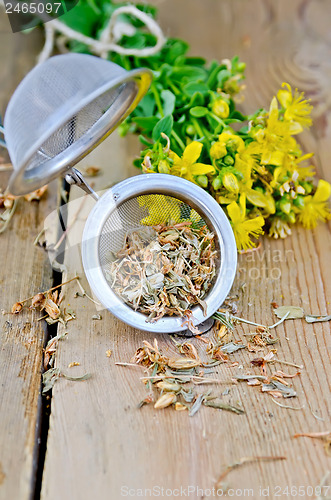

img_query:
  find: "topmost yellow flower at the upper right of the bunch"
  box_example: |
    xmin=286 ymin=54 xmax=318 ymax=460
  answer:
xmin=277 ymin=82 xmax=313 ymax=133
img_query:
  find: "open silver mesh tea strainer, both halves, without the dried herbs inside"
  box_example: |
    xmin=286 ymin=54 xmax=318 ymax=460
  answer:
xmin=4 ymin=54 xmax=237 ymax=333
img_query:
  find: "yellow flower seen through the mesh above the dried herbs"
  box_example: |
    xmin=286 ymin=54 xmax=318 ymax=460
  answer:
xmin=137 ymin=194 xmax=181 ymax=226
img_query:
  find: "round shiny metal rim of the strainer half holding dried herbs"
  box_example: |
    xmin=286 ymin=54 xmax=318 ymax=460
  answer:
xmin=82 ymin=174 xmax=237 ymax=333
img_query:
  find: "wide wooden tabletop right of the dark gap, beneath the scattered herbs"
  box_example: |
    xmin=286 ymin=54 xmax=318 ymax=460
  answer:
xmin=42 ymin=0 xmax=331 ymax=500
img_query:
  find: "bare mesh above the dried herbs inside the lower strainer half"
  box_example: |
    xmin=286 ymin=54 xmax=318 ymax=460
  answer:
xmin=99 ymin=194 xmax=217 ymax=279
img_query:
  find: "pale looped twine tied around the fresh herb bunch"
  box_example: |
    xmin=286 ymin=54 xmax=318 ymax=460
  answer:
xmin=37 ymin=5 xmax=166 ymax=64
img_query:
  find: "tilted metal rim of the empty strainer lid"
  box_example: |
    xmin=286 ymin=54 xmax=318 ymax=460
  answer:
xmin=4 ymin=61 xmax=153 ymax=196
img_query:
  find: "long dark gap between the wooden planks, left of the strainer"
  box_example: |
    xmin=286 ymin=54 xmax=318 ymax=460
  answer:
xmin=30 ymin=180 xmax=70 ymax=500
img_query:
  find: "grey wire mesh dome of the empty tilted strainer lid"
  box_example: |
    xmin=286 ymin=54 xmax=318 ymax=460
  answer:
xmin=4 ymin=54 xmax=137 ymax=169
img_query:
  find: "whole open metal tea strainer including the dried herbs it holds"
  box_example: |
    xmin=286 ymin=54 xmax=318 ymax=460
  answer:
xmin=4 ymin=54 xmax=237 ymax=333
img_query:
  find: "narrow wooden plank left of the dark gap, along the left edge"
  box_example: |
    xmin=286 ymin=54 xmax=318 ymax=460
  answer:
xmin=0 ymin=10 xmax=56 ymax=500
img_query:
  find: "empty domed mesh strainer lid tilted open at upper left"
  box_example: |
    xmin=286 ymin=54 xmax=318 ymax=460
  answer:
xmin=4 ymin=54 xmax=152 ymax=195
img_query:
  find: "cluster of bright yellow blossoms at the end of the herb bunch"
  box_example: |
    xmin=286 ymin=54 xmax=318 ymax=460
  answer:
xmin=131 ymin=83 xmax=331 ymax=250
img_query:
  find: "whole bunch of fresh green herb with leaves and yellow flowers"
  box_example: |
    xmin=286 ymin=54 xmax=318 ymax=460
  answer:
xmin=63 ymin=0 xmax=331 ymax=250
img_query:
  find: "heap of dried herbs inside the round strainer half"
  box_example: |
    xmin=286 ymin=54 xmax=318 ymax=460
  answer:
xmin=106 ymin=221 xmax=218 ymax=330
